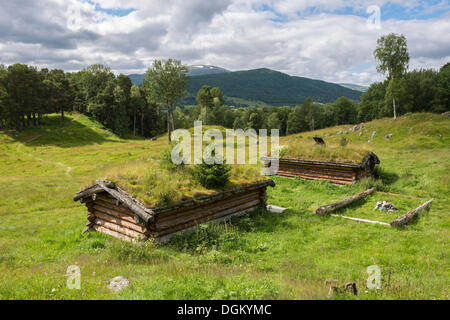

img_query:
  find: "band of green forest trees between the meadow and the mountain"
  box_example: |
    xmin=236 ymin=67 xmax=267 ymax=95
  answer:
xmin=0 ymin=63 xmax=450 ymax=137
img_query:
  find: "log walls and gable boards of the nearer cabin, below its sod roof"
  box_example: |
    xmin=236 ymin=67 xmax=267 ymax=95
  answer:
xmin=74 ymin=179 xmax=275 ymax=242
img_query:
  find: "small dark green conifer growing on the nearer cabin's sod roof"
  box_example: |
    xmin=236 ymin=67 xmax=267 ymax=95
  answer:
xmin=193 ymin=160 xmax=231 ymax=189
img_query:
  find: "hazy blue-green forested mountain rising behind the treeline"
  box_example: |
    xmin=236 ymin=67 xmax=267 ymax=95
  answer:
xmin=129 ymin=66 xmax=362 ymax=106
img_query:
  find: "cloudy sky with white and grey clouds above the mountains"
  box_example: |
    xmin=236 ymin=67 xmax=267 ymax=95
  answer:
xmin=0 ymin=0 xmax=450 ymax=84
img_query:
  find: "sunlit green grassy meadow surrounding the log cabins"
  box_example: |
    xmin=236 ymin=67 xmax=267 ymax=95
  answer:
xmin=0 ymin=114 xmax=450 ymax=299
